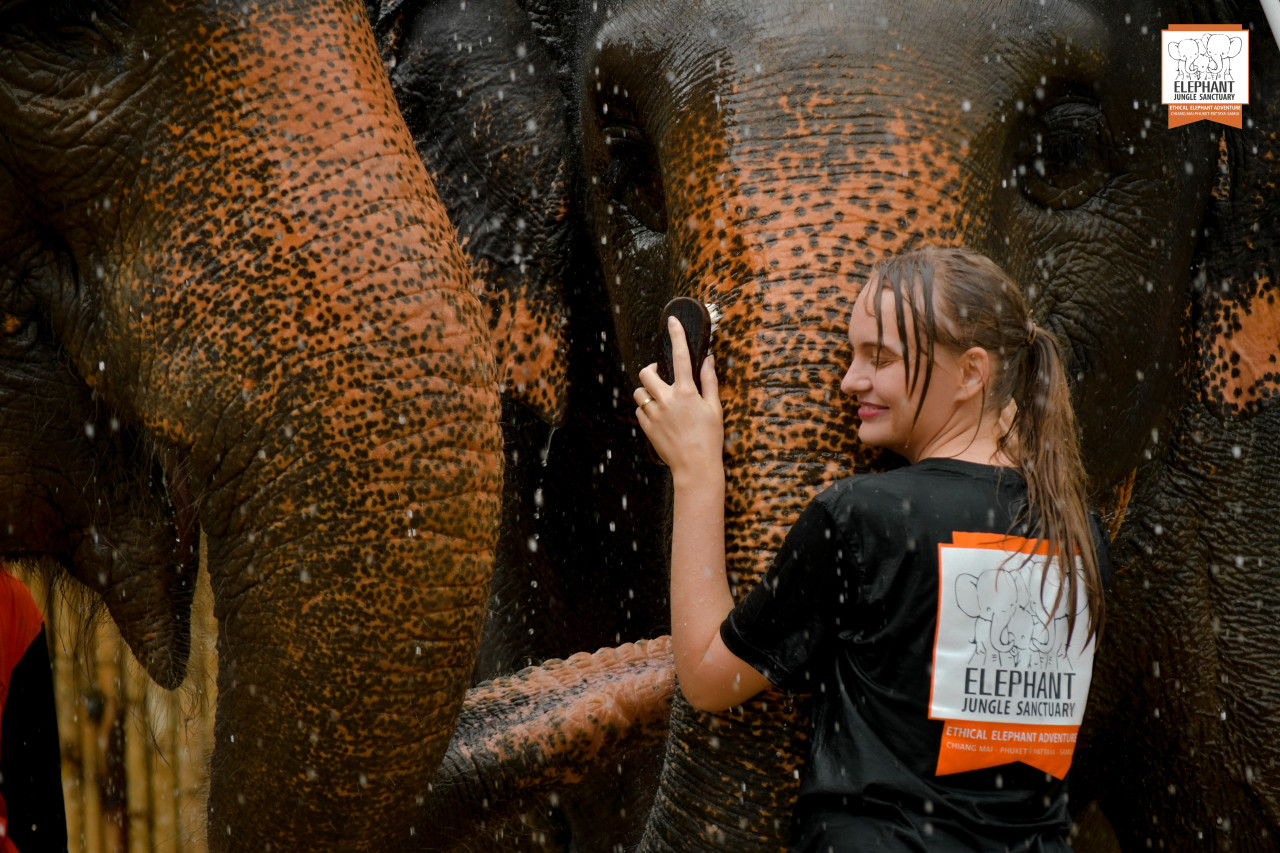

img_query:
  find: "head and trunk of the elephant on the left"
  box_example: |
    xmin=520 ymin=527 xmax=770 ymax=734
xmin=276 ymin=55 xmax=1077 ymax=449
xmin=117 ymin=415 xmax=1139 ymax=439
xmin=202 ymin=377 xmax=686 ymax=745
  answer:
xmin=0 ymin=0 xmax=500 ymax=849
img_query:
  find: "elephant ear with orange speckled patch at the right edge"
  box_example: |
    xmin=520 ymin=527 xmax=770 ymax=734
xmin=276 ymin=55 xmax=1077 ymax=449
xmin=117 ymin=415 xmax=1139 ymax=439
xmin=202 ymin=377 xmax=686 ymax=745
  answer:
xmin=1194 ymin=20 xmax=1280 ymax=418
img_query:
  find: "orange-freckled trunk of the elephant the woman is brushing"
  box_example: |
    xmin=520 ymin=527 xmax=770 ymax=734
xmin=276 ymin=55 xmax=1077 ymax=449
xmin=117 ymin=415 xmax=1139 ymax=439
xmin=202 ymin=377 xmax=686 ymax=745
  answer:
xmin=643 ymin=81 xmax=961 ymax=850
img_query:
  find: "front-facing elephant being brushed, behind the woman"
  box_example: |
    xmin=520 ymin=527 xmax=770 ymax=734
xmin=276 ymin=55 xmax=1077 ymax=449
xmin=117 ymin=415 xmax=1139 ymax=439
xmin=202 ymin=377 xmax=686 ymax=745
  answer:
xmin=371 ymin=0 xmax=1280 ymax=852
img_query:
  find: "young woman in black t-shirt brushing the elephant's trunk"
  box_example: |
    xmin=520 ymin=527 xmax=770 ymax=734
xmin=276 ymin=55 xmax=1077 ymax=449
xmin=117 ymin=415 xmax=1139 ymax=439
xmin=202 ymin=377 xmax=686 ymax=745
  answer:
xmin=635 ymin=247 xmax=1110 ymax=853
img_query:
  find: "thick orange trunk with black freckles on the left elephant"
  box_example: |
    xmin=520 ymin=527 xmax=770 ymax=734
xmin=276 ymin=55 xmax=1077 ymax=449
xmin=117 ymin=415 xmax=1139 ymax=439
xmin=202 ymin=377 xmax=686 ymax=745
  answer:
xmin=57 ymin=0 xmax=502 ymax=850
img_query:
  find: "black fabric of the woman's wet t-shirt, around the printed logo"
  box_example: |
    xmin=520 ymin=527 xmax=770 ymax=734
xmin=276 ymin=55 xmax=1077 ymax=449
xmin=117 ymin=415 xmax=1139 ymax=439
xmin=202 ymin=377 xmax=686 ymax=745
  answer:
xmin=721 ymin=459 xmax=1110 ymax=852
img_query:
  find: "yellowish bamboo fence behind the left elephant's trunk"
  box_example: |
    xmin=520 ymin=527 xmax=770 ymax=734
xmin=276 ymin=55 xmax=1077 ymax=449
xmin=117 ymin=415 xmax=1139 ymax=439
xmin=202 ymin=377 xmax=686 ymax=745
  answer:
xmin=28 ymin=558 xmax=218 ymax=853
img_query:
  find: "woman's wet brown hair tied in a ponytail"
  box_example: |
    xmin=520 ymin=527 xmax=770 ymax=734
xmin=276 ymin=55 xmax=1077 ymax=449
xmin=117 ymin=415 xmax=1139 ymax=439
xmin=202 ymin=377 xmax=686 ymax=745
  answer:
xmin=868 ymin=246 xmax=1103 ymax=642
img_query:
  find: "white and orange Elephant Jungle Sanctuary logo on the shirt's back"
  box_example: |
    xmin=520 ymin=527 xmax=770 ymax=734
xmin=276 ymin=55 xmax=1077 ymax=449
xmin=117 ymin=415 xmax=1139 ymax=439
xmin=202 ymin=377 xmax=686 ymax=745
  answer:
xmin=929 ymin=533 xmax=1094 ymax=779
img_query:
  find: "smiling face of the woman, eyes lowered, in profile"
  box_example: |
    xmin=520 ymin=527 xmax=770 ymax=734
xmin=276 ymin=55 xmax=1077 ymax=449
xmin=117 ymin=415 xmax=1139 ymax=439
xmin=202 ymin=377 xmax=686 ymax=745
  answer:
xmin=840 ymin=275 xmax=960 ymax=462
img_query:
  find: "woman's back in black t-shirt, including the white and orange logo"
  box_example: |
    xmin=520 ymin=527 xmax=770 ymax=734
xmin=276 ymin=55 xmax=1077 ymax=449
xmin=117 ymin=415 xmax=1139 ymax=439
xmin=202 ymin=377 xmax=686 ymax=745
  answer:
xmin=722 ymin=459 xmax=1106 ymax=849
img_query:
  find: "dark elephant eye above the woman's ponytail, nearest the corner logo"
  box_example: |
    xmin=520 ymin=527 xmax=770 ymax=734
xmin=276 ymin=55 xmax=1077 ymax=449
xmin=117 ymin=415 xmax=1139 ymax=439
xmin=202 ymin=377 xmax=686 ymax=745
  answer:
xmin=1018 ymin=101 xmax=1115 ymax=210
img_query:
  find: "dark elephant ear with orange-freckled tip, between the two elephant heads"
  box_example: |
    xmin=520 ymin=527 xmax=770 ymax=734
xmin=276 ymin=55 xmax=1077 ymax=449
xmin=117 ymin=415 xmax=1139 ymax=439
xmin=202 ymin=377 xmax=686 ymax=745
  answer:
xmin=371 ymin=0 xmax=570 ymax=425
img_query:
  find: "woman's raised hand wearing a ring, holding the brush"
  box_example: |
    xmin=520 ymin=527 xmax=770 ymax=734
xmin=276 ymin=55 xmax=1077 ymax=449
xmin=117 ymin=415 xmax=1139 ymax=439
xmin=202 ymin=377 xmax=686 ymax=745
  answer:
xmin=635 ymin=312 xmax=724 ymax=488
